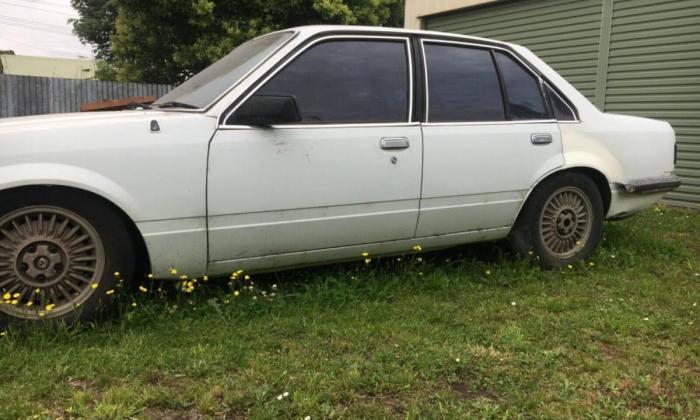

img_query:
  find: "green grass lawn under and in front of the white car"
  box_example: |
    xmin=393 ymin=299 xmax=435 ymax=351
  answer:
xmin=0 ymin=207 xmax=700 ymax=419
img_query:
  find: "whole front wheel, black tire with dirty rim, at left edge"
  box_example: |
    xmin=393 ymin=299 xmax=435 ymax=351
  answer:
xmin=0 ymin=187 xmax=135 ymax=327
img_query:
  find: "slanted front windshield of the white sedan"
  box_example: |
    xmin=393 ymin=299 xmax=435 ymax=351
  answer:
xmin=154 ymin=32 xmax=294 ymax=108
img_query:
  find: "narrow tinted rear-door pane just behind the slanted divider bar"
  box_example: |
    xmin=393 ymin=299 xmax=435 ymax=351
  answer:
xmin=495 ymin=52 xmax=549 ymax=120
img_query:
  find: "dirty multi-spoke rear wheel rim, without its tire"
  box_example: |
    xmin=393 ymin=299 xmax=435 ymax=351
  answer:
xmin=540 ymin=187 xmax=593 ymax=258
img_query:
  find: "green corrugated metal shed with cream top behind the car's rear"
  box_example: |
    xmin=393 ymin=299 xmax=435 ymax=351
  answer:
xmin=421 ymin=0 xmax=700 ymax=207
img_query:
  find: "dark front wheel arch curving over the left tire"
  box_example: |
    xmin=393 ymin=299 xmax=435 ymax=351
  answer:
xmin=0 ymin=184 xmax=151 ymax=274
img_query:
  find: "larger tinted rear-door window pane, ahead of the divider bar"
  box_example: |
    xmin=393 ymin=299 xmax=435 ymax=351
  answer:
xmin=425 ymin=44 xmax=505 ymax=122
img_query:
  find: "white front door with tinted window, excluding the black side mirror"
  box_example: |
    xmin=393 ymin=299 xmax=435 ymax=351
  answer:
xmin=207 ymin=36 xmax=422 ymax=262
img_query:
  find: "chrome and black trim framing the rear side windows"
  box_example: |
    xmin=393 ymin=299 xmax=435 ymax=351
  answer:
xmin=420 ymin=37 xmax=580 ymax=126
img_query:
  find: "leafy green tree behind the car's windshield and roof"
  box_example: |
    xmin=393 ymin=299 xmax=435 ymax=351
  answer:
xmin=71 ymin=0 xmax=403 ymax=84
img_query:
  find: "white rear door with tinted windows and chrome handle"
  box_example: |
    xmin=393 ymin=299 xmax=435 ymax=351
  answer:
xmin=416 ymin=40 xmax=564 ymax=236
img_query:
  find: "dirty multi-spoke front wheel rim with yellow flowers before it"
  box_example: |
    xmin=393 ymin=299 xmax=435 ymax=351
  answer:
xmin=0 ymin=207 xmax=105 ymax=319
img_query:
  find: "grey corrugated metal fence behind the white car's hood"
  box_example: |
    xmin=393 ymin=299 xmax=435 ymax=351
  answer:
xmin=0 ymin=74 xmax=172 ymax=118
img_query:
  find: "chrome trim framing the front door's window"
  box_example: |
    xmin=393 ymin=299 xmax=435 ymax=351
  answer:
xmin=218 ymin=34 xmax=416 ymax=129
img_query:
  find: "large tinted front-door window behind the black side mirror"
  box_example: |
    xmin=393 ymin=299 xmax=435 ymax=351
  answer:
xmin=230 ymin=40 xmax=409 ymax=124
